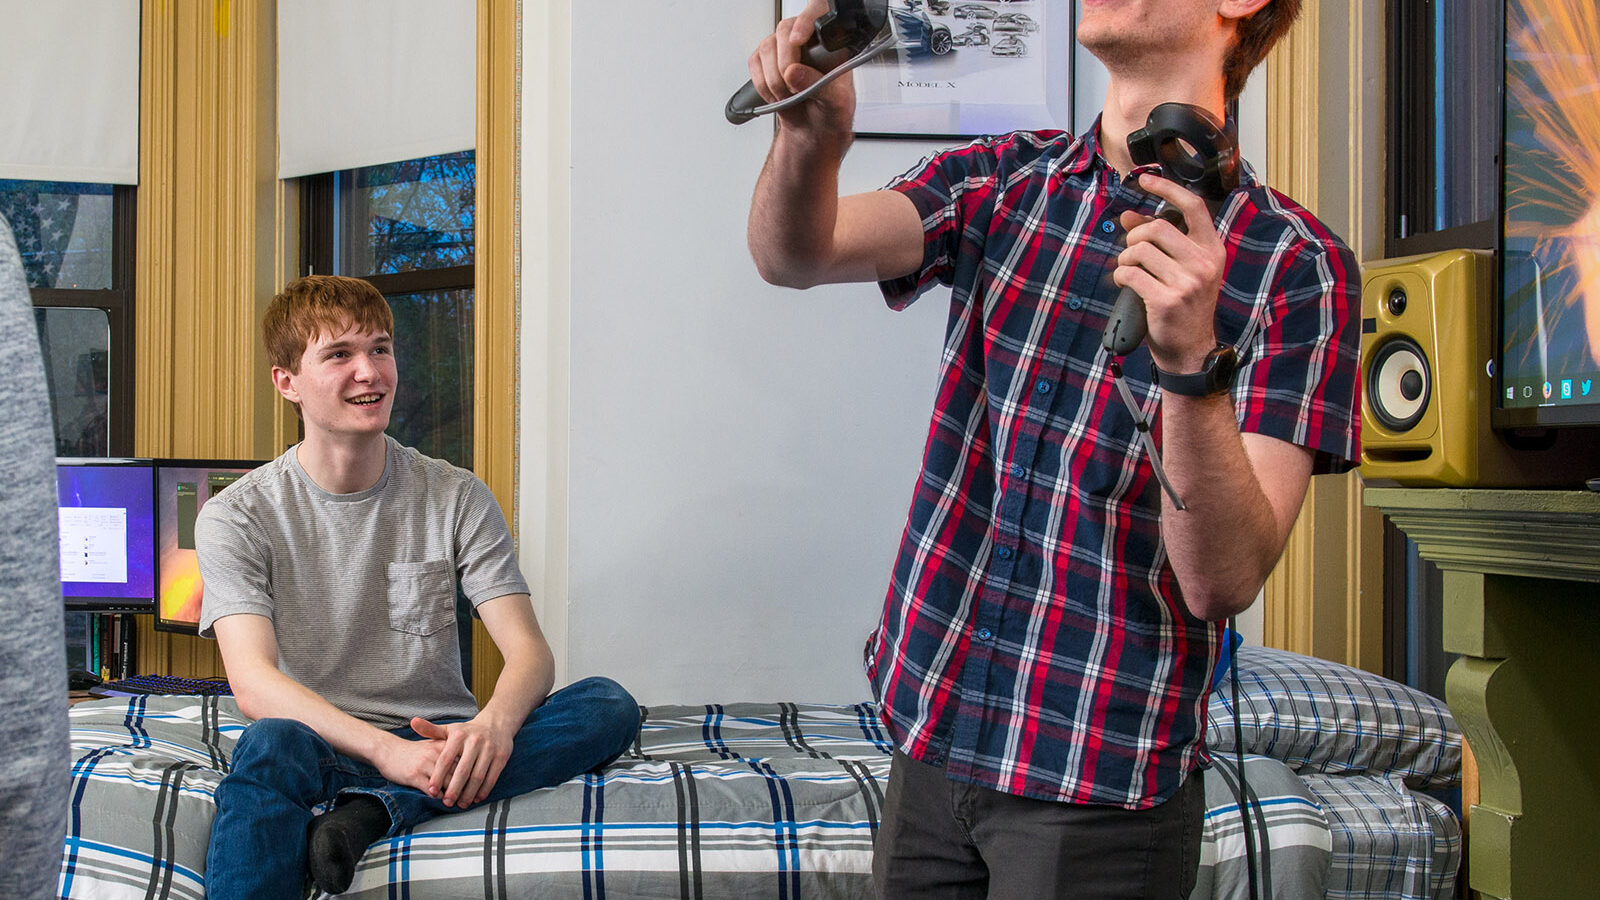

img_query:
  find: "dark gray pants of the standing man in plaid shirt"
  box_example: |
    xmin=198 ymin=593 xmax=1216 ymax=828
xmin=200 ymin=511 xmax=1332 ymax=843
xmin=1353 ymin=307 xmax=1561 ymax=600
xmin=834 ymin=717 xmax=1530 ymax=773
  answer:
xmin=872 ymin=751 xmax=1205 ymax=900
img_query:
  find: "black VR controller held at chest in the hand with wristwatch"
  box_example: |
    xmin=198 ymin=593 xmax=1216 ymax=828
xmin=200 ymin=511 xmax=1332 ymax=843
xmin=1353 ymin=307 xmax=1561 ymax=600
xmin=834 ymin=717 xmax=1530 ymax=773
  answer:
xmin=1101 ymin=102 xmax=1238 ymax=356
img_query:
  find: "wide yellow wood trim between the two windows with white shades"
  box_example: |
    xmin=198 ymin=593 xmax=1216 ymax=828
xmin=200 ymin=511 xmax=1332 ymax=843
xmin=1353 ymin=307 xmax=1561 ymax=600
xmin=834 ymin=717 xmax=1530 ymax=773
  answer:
xmin=134 ymin=0 xmax=285 ymax=676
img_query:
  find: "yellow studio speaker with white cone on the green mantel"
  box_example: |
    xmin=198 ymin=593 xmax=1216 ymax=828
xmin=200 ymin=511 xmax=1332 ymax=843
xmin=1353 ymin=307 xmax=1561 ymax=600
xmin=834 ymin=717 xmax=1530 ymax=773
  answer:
xmin=1362 ymin=250 xmax=1582 ymax=487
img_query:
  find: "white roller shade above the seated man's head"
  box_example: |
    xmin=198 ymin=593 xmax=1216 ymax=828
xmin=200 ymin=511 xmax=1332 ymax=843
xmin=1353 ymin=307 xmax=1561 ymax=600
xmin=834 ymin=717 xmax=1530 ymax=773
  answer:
xmin=278 ymin=0 xmax=477 ymax=178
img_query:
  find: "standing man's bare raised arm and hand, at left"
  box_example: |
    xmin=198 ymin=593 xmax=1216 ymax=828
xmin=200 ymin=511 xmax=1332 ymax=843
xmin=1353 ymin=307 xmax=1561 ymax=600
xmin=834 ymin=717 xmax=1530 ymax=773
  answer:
xmin=749 ymin=0 xmax=923 ymax=288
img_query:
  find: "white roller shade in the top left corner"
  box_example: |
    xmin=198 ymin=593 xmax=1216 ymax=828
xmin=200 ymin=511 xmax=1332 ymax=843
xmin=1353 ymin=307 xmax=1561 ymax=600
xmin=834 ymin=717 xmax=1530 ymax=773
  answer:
xmin=0 ymin=0 xmax=139 ymax=184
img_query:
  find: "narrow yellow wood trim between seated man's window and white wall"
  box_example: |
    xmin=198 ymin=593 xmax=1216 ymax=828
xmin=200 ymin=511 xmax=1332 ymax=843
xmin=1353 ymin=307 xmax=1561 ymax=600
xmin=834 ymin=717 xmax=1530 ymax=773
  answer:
xmin=472 ymin=0 xmax=522 ymax=703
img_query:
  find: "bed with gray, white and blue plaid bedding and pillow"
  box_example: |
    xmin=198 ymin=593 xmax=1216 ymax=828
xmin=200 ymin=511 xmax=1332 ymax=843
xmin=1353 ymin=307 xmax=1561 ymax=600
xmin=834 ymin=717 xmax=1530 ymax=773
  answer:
xmin=59 ymin=649 xmax=1462 ymax=900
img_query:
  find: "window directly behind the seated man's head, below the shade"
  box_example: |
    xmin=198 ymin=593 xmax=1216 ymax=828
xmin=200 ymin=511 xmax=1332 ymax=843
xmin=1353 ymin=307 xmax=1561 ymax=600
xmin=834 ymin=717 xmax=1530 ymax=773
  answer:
xmin=301 ymin=151 xmax=477 ymax=468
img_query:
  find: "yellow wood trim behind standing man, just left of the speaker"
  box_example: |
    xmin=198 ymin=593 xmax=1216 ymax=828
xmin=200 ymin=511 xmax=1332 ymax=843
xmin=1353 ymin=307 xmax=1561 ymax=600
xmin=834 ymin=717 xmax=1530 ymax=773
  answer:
xmin=1264 ymin=0 xmax=1384 ymax=671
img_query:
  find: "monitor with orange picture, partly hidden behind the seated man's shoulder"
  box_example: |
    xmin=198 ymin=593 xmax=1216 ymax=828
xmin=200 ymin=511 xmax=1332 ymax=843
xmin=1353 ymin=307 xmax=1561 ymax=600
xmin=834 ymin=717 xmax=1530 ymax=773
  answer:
xmin=155 ymin=460 xmax=261 ymax=634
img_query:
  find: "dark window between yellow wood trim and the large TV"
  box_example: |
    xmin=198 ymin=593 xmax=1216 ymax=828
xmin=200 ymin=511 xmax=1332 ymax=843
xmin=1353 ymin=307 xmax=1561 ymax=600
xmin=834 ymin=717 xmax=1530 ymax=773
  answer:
xmin=1386 ymin=0 xmax=1504 ymax=256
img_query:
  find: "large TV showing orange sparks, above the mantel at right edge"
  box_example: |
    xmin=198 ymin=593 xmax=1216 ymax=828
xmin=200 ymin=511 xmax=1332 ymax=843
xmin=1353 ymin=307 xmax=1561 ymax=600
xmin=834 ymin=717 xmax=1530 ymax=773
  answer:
xmin=1494 ymin=0 xmax=1600 ymax=429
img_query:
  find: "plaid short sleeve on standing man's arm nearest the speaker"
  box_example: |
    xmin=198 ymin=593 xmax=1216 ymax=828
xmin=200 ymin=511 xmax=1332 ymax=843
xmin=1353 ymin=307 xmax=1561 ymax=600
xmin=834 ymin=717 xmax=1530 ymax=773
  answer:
xmin=1235 ymin=243 xmax=1362 ymax=474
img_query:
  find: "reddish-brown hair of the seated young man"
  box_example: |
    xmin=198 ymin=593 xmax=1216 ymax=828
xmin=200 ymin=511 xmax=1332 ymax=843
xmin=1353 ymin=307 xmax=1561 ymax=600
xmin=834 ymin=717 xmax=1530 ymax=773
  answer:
xmin=261 ymin=275 xmax=395 ymax=375
